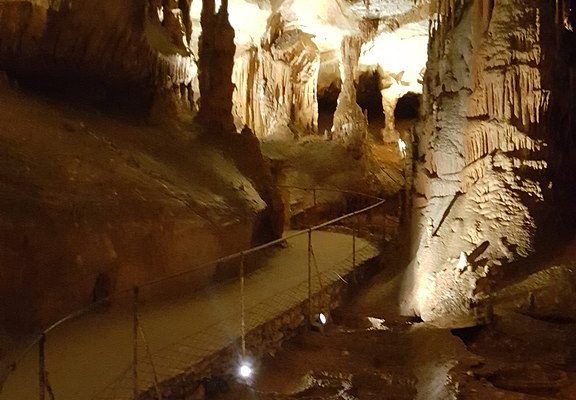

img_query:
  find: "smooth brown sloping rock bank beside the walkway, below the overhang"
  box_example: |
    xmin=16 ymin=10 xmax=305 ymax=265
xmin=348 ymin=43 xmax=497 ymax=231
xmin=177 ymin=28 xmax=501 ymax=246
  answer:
xmin=0 ymin=88 xmax=274 ymax=332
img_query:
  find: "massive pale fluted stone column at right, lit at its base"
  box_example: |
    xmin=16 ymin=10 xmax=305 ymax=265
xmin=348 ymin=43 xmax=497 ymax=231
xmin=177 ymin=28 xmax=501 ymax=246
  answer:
xmin=403 ymin=0 xmax=573 ymax=327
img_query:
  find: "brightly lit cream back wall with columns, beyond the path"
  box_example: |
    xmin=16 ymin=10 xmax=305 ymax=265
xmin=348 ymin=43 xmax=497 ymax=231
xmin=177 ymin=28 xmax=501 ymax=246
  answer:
xmin=230 ymin=0 xmax=429 ymax=142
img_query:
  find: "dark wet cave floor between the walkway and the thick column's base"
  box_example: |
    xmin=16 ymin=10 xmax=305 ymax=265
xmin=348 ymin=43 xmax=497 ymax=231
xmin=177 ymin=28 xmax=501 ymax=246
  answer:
xmin=213 ymin=245 xmax=576 ymax=400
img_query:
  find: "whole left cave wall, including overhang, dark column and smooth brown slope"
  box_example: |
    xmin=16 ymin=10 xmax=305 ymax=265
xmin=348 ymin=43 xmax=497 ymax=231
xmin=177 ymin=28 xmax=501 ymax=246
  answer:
xmin=0 ymin=0 xmax=283 ymax=333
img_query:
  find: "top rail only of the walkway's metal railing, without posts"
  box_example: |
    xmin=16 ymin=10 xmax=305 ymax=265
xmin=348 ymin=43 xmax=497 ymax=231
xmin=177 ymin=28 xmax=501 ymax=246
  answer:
xmin=1 ymin=185 xmax=386 ymax=386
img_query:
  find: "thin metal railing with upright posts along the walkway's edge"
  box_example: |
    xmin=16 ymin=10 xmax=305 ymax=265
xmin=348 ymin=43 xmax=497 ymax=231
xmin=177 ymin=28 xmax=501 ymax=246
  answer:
xmin=0 ymin=186 xmax=392 ymax=400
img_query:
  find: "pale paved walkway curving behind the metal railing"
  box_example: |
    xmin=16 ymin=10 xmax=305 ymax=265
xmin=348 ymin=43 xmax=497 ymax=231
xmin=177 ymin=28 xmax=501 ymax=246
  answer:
xmin=0 ymin=231 xmax=378 ymax=400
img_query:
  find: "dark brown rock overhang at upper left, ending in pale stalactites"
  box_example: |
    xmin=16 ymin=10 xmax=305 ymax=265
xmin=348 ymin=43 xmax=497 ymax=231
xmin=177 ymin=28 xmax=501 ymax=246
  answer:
xmin=0 ymin=0 xmax=198 ymax=115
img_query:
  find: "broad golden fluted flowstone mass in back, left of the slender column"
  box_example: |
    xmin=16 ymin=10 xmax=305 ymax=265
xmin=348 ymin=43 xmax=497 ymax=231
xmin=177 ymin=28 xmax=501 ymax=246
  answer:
xmin=234 ymin=13 xmax=320 ymax=139
